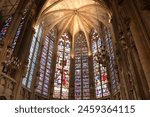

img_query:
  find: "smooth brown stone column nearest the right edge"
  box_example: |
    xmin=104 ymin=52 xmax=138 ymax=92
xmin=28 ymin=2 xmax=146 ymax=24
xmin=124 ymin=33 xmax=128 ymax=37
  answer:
xmin=130 ymin=1 xmax=150 ymax=97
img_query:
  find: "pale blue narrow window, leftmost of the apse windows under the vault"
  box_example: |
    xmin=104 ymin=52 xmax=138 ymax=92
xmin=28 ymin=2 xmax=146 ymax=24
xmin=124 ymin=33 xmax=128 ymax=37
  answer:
xmin=22 ymin=26 xmax=42 ymax=89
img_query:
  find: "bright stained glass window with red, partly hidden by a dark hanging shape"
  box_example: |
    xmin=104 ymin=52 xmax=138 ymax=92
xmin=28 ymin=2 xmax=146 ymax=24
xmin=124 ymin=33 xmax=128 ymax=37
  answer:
xmin=92 ymin=30 xmax=110 ymax=98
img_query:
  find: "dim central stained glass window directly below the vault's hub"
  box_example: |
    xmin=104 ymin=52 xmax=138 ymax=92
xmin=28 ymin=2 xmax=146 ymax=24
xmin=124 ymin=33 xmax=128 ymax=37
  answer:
xmin=75 ymin=33 xmax=90 ymax=99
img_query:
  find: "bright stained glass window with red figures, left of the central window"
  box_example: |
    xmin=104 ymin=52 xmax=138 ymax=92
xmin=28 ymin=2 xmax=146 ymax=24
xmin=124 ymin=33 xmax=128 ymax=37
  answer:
xmin=53 ymin=33 xmax=71 ymax=99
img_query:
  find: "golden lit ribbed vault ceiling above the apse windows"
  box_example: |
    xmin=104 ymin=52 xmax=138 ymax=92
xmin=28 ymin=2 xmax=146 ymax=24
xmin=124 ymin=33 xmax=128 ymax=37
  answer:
xmin=38 ymin=0 xmax=110 ymax=54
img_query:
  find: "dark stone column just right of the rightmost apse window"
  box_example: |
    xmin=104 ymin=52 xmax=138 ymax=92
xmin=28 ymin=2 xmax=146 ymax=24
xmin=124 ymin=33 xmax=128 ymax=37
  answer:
xmin=109 ymin=1 xmax=129 ymax=99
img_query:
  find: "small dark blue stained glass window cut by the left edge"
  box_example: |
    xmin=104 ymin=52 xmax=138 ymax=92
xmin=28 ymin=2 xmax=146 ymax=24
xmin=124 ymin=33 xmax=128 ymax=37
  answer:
xmin=0 ymin=16 xmax=12 ymax=41
